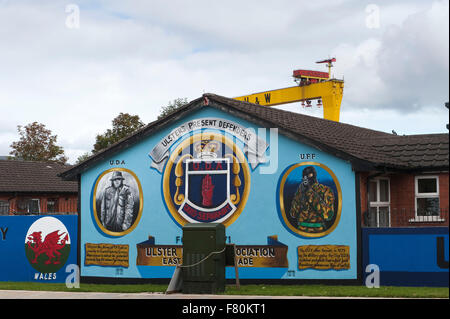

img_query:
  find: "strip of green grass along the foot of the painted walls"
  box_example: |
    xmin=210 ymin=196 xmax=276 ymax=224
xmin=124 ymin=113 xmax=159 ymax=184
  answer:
xmin=0 ymin=282 xmax=449 ymax=298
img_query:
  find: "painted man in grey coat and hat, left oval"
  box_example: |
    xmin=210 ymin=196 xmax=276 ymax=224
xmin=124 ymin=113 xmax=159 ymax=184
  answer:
xmin=100 ymin=171 xmax=134 ymax=232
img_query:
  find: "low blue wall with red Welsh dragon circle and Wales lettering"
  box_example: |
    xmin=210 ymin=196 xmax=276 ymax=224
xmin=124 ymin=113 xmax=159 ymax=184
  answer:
xmin=0 ymin=215 xmax=78 ymax=283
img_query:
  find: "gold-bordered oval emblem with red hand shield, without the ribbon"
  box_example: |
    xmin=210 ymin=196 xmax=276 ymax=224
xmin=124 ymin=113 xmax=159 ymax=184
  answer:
xmin=163 ymin=133 xmax=250 ymax=225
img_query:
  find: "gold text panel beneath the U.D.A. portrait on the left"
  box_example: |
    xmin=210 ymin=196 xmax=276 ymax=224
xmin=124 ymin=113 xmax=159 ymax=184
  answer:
xmin=84 ymin=243 xmax=130 ymax=267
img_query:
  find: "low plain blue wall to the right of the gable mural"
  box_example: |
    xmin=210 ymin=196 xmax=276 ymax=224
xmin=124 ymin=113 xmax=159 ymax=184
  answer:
xmin=362 ymin=227 xmax=449 ymax=287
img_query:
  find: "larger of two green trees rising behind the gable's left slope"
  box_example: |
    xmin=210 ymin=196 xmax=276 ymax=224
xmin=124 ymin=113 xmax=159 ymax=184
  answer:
xmin=92 ymin=113 xmax=144 ymax=154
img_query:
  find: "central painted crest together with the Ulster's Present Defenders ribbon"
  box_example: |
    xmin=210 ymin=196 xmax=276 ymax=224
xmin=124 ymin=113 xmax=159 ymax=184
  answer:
xmin=149 ymin=118 xmax=269 ymax=226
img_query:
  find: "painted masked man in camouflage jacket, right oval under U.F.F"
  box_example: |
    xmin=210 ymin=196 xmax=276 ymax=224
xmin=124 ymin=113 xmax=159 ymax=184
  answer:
xmin=289 ymin=166 xmax=334 ymax=233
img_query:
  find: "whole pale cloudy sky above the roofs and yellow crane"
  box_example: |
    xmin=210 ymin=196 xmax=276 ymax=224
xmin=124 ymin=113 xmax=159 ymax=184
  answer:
xmin=0 ymin=0 xmax=449 ymax=163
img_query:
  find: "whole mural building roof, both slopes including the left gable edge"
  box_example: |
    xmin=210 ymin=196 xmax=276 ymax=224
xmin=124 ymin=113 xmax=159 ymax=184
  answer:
xmin=61 ymin=93 xmax=449 ymax=179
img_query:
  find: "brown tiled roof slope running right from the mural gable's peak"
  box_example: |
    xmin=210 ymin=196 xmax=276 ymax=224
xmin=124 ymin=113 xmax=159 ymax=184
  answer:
xmin=209 ymin=94 xmax=449 ymax=169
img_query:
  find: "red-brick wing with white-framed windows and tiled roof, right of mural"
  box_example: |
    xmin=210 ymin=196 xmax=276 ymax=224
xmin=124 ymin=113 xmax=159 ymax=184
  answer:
xmin=360 ymin=134 xmax=449 ymax=227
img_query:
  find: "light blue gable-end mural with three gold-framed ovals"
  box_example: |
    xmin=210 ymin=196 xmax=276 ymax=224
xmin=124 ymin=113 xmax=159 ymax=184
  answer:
xmin=80 ymin=109 xmax=357 ymax=279
